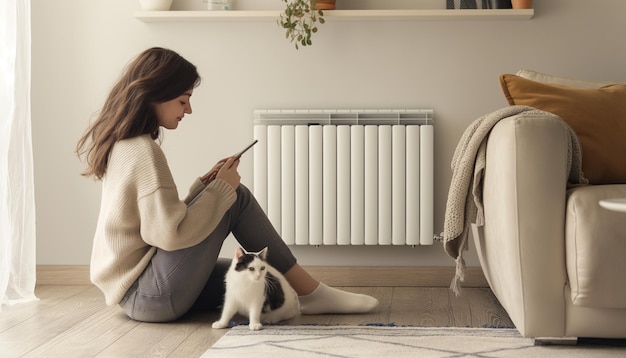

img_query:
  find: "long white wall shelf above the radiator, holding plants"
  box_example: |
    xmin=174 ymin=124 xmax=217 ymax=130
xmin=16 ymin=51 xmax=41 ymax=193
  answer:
xmin=135 ymin=9 xmax=535 ymax=22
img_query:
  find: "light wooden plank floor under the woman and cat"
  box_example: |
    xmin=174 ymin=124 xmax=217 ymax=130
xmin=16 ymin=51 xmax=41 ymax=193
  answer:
xmin=0 ymin=285 xmax=513 ymax=358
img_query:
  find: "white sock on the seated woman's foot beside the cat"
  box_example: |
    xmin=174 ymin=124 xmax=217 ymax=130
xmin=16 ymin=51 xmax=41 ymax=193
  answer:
xmin=298 ymin=283 xmax=378 ymax=314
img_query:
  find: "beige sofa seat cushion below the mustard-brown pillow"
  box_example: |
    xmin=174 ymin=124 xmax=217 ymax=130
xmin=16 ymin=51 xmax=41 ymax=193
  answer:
xmin=565 ymin=184 xmax=626 ymax=308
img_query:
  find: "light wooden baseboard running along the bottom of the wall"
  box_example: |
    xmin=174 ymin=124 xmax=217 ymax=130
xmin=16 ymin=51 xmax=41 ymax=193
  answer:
xmin=37 ymin=265 xmax=489 ymax=287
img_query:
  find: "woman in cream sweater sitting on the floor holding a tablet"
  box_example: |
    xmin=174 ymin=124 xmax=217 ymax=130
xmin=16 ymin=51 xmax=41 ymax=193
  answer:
xmin=76 ymin=48 xmax=378 ymax=322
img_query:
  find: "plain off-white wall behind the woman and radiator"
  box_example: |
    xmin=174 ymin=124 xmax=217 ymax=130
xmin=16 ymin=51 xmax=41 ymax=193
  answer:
xmin=32 ymin=0 xmax=626 ymax=266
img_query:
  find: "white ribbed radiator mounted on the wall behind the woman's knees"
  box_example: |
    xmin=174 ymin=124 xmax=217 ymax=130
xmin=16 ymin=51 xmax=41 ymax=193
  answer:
xmin=253 ymin=109 xmax=434 ymax=245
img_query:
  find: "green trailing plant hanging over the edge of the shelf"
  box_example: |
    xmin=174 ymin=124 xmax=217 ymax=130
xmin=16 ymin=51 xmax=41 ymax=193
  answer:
xmin=278 ymin=0 xmax=326 ymax=50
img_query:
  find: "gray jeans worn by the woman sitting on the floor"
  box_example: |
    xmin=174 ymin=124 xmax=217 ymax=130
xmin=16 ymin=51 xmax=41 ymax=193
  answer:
xmin=120 ymin=185 xmax=296 ymax=322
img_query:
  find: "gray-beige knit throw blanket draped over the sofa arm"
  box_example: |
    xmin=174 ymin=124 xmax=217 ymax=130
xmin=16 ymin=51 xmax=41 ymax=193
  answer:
xmin=441 ymin=106 xmax=587 ymax=295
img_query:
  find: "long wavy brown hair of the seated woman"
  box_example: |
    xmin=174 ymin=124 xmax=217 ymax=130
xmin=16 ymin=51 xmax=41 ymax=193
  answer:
xmin=76 ymin=47 xmax=200 ymax=179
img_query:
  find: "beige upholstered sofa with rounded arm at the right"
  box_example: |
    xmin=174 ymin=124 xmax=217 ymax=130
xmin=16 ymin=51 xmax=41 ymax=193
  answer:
xmin=472 ymin=73 xmax=626 ymax=338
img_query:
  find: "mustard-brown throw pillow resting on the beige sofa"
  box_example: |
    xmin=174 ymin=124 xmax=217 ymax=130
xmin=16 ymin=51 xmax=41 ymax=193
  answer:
xmin=500 ymin=74 xmax=626 ymax=184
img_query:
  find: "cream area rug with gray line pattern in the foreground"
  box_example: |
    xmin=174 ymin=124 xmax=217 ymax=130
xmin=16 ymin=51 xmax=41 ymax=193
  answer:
xmin=202 ymin=326 xmax=626 ymax=358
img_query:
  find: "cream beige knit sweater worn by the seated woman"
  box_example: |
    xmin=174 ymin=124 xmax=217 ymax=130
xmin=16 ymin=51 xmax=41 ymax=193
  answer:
xmin=90 ymin=135 xmax=237 ymax=305
